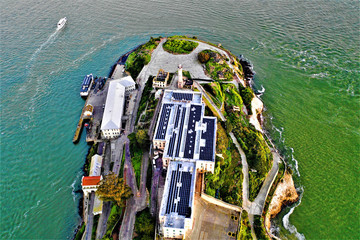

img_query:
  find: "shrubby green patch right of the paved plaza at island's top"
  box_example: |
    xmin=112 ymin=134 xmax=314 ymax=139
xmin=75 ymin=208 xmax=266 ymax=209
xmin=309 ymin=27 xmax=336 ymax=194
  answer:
xmin=198 ymin=50 xmax=233 ymax=81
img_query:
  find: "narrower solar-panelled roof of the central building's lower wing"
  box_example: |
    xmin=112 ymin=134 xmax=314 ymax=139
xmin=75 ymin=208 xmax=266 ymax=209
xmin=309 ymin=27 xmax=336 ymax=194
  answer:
xmin=160 ymin=161 xmax=196 ymax=228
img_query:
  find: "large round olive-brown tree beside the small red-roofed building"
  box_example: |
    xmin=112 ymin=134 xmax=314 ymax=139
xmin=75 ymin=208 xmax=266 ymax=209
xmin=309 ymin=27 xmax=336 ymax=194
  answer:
xmin=96 ymin=173 xmax=132 ymax=207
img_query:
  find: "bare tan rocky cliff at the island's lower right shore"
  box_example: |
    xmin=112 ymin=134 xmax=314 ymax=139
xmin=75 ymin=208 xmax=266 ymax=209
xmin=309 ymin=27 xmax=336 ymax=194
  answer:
xmin=265 ymin=173 xmax=299 ymax=233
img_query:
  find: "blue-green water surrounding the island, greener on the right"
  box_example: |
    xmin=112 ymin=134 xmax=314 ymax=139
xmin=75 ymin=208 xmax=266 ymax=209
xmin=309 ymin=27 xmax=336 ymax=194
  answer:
xmin=0 ymin=0 xmax=360 ymax=239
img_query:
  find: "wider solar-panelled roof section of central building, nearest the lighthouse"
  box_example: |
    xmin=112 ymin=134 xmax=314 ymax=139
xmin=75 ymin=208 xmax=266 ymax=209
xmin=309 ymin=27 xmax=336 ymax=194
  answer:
xmin=154 ymin=90 xmax=216 ymax=161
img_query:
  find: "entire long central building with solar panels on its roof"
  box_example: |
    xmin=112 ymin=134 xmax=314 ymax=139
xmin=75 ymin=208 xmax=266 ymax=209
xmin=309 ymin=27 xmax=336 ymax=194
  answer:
xmin=153 ymin=90 xmax=216 ymax=238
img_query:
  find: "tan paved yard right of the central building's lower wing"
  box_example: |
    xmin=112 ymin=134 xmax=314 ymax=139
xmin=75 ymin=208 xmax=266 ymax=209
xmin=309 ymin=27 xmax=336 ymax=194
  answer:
xmin=186 ymin=196 xmax=240 ymax=240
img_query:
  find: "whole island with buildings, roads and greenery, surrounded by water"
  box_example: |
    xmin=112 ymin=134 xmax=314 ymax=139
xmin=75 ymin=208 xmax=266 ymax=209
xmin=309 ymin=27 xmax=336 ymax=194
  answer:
xmin=73 ymin=36 xmax=298 ymax=239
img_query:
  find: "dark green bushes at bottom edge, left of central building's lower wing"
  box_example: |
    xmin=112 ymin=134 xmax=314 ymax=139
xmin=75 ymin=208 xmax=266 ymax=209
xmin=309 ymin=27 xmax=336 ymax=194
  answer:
xmin=134 ymin=208 xmax=155 ymax=240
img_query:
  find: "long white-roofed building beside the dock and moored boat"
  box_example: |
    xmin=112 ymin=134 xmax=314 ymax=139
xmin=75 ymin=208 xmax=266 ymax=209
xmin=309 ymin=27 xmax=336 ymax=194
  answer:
xmin=100 ymin=80 xmax=125 ymax=139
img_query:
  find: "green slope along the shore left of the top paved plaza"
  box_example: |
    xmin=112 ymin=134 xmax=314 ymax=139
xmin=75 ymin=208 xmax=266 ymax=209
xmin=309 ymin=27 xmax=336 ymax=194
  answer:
xmin=125 ymin=37 xmax=160 ymax=79
